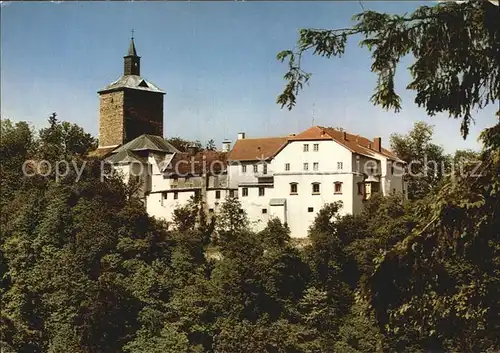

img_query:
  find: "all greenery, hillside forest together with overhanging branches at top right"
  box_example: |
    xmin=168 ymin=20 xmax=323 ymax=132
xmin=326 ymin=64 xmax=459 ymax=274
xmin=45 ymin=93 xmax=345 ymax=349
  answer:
xmin=0 ymin=1 xmax=500 ymax=353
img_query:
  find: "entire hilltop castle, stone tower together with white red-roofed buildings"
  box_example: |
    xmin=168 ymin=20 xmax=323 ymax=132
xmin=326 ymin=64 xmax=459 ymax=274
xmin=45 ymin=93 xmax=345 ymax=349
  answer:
xmin=96 ymin=38 xmax=406 ymax=238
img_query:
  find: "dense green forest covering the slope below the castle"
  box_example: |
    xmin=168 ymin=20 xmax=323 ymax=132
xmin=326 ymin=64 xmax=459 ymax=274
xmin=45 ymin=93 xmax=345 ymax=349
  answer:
xmin=0 ymin=115 xmax=500 ymax=353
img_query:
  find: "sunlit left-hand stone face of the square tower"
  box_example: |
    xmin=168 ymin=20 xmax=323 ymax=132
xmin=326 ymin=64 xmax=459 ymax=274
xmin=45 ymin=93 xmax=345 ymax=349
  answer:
xmin=99 ymin=91 xmax=124 ymax=147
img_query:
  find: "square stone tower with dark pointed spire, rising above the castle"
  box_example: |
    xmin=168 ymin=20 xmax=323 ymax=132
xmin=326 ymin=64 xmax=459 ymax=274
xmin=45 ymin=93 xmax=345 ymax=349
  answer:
xmin=98 ymin=37 xmax=165 ymax=148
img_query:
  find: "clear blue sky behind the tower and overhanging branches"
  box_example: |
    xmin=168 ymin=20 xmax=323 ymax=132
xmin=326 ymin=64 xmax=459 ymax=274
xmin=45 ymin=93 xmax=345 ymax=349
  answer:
xmin=1 ymin=1 xmax=496 ymax=152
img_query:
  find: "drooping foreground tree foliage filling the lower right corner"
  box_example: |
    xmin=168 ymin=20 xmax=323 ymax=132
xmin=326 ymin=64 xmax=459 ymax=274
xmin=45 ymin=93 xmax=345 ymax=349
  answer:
xmin=367 ymin=119 xmax=500 ymax=351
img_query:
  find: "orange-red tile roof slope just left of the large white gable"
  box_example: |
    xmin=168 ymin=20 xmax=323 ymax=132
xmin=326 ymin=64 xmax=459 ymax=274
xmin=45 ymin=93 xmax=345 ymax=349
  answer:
xmin=227 ymin=137 xmax=288 ymax=161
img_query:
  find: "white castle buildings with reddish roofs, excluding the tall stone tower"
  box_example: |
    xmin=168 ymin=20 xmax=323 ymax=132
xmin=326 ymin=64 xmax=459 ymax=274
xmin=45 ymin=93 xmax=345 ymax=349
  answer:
xmin=103 ymin=126 xmax=406 ymax=238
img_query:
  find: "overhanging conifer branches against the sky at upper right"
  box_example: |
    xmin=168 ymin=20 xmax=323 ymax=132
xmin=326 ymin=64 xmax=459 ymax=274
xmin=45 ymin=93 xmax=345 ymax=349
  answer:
xmin=277 ymin=1 xmax=500 ymax=138
